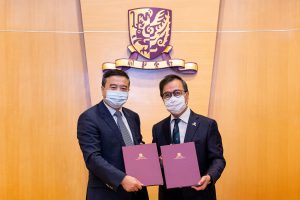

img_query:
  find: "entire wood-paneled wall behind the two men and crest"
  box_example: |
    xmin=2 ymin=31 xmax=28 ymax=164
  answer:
xmin=0 ymin=0 xmax=300 ymax=200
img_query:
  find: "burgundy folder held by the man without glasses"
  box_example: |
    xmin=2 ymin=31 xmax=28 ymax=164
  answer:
xmin=122 ymin=143 xmax=163 ymax=186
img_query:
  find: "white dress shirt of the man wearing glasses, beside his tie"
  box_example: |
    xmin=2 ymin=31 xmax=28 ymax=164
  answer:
xmin=170 ymin=108 xmax=191 ymax=143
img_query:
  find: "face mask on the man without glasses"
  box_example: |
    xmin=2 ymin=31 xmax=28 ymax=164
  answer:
xmin=104 ymin=90 xmax=128 ymax=109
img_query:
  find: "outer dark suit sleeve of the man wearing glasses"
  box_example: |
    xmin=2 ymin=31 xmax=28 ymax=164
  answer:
xmin=207 ymin=120 xmax=226 ymax=183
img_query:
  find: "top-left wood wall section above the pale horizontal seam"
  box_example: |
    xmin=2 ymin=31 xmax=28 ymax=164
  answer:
xmin=0 ymin=0 xmax=81 ymax=32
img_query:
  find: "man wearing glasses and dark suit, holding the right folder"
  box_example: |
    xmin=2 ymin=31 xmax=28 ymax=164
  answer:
xmin=152 ymin=75 xmax=226 ymax=200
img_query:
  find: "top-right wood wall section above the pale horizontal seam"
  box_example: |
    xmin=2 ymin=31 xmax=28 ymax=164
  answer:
xmin=220 ymin=0 xmax=300 ymax=31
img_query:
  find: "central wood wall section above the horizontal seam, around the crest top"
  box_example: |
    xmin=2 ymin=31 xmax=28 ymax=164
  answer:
xmin=81 ymin=0 xmax=220 ymax=31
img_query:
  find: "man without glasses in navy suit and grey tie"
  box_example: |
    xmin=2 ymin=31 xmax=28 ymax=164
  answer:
xmin=77 ymin=70 xmax=148 ymax=200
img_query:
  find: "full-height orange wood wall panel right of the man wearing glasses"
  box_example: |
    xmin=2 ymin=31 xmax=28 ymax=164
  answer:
xmin=209 ymin=0 xmax=300 ymax=200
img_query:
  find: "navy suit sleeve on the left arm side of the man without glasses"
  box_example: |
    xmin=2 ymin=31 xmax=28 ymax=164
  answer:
xmin=77 ymin=114 xmax=126 ymax=190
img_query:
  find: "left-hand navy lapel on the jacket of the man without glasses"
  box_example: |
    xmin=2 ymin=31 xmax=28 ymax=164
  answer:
xmin=99 ymin=101 xmax=125 ymax=146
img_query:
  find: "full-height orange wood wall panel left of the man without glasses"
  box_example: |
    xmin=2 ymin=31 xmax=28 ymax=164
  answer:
xmin=0 ymin=0 xmax=90 ymax=200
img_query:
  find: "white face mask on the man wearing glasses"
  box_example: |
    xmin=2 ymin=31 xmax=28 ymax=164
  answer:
xmin=164 ymin=95 xmax=187 ymax=115
